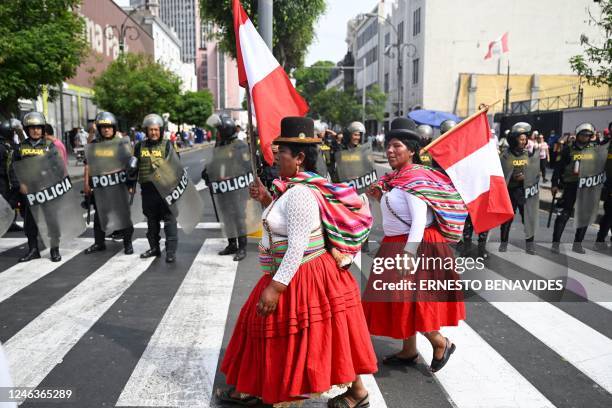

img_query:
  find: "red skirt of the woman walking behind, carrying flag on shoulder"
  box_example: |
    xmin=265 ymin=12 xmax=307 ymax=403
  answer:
xmin=362 ymin=226 xmax=465 ymax=339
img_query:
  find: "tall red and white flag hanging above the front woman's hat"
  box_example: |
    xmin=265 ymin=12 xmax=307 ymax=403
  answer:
xmin=233 ymin=0 xmax=308 ymax=164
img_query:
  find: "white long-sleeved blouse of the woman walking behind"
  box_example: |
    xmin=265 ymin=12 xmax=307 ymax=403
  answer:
xmin=380 ymin=188 xmax=434 ymax=254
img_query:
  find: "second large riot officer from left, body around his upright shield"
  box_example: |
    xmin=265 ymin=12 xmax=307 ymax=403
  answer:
xmin=85 ymin=112 xmax=134 ymax=255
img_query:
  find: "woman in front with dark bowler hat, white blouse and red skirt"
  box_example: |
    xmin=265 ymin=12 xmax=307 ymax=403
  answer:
xmin=217 ymin=117 xmax=377 ymax=408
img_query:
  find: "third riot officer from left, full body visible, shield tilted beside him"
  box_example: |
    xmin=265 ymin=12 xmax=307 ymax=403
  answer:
xmin=130 ymin=113 xmax=178 ymax=263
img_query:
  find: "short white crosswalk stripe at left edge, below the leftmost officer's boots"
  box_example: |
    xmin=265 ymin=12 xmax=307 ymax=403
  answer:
xmin=0 ymin=238 xmax=93 ymax=302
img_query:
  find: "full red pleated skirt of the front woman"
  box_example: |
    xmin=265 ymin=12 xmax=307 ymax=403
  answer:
xmin=221 ymin=253 xmax=377 ymax=404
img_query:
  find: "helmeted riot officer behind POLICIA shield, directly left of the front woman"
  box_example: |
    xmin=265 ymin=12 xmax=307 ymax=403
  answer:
xmin=202 ymin=115 xmax=247 ymax=261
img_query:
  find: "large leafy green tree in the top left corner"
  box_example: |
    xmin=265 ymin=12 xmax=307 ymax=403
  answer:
xmin=0 ymin=0 xmax=88 ymax=116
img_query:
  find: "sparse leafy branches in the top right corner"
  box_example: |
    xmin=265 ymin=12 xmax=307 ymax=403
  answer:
xmin=570 ymin=0 xmax=612 ymax=86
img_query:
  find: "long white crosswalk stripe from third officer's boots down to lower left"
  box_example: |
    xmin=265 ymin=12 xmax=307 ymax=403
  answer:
xmin=5 ymin=239 xmax=155 ymax=387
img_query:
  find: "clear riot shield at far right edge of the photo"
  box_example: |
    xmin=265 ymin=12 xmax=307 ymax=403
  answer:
xmin=574 ymin=144 xmax=608 ymax=228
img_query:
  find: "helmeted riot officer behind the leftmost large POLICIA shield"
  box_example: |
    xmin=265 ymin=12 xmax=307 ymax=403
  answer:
xmin=15 ymin=112 xmax=62 ymax=262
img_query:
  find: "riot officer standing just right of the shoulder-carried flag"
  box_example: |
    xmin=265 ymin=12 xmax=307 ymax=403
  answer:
xmin=499 ymin=122 xmax=536 ymax=255
